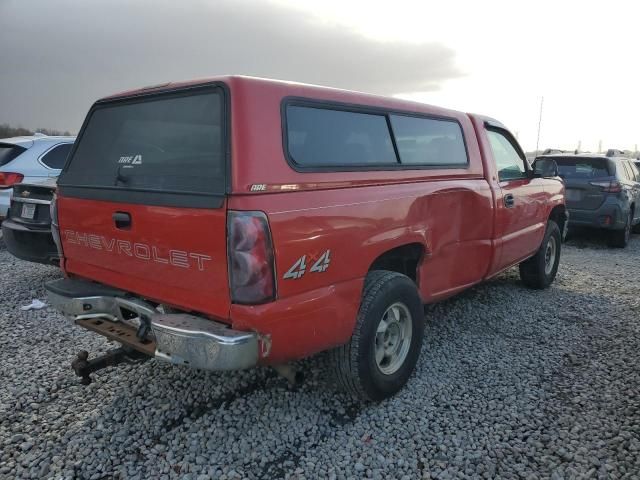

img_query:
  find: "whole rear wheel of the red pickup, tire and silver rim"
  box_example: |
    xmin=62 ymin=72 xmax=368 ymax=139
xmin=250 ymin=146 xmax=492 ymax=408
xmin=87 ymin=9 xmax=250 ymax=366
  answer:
xmin=329 ymin=270 xmax=424 ymax=400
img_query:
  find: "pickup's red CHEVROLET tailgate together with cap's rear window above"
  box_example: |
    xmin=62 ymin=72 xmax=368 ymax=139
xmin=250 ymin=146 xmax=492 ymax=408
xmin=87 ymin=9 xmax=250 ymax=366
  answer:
xmin=57 ymin=85 xmax=230 ymax=319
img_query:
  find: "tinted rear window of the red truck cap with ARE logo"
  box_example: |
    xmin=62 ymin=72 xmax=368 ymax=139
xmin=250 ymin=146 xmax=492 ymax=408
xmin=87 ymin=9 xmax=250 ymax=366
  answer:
xmin=60 ymin=87 xmax=226 ymax=194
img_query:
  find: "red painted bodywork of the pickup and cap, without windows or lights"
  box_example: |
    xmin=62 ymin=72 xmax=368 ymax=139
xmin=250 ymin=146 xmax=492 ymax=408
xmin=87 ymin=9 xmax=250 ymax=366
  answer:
xmin=59 ymin=77 xmax=564 ymax=363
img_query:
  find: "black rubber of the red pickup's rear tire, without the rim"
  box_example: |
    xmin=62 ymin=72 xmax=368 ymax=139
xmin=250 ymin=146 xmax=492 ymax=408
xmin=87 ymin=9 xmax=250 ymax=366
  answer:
xmin=329 ymin=270 xmax=424 ymax=401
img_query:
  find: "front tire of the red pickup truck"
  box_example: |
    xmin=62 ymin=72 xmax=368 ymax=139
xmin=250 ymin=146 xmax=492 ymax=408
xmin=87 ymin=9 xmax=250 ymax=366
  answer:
xmin=520 ymin=220 xmax=562 ymax=289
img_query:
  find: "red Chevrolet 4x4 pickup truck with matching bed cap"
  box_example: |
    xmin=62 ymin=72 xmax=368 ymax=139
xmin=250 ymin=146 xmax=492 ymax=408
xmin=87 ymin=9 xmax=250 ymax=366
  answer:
xmin=47 ymin=76 xmax=566 ymax=400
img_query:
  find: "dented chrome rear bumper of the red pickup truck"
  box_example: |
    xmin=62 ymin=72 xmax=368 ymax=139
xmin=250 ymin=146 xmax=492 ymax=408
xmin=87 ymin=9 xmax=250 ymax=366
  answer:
xmin=46 ymin=279 xmax=261 ymax=370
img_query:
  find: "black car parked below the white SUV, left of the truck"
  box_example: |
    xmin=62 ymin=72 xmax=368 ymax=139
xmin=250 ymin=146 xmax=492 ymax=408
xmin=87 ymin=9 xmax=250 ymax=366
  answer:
xmin=2 ymin=178 xmax=60 ymax=265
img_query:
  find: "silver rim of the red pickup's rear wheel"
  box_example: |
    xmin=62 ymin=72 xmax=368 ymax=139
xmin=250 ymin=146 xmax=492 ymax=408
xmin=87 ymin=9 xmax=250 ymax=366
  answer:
xmin=375 ymin=302 xmax=413 ymax=375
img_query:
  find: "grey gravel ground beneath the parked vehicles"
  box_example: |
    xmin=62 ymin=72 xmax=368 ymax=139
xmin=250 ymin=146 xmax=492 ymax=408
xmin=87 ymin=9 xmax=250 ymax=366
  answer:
xmin=0 ymin=232 xmax=640 ymax=479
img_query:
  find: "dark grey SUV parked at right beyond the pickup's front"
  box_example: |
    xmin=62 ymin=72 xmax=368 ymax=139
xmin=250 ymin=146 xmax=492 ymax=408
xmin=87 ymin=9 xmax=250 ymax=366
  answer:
xmin=536 ymin=150 xmax=640 ymax=248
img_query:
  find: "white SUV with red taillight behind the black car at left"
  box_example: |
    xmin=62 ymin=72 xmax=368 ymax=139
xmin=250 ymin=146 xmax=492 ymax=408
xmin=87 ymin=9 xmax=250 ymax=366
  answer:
xmin=0 ymin=134 xmax=75 ymax=221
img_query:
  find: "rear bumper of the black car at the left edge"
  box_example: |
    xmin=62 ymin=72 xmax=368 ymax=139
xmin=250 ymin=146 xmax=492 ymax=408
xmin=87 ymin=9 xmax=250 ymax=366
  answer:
xmin=2 ymin=219 xmax=60 ymax=265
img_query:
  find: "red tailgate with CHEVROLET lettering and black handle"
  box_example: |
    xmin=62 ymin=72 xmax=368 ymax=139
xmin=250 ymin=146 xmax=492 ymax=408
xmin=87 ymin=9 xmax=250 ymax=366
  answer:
xmin=58 ymin=197 xmax=230 ymax=319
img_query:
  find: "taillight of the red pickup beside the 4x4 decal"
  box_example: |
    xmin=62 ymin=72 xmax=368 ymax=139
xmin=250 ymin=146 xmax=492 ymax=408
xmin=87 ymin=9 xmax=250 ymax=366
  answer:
xmin=227 ymin=211 xmax=276 ymax=304
